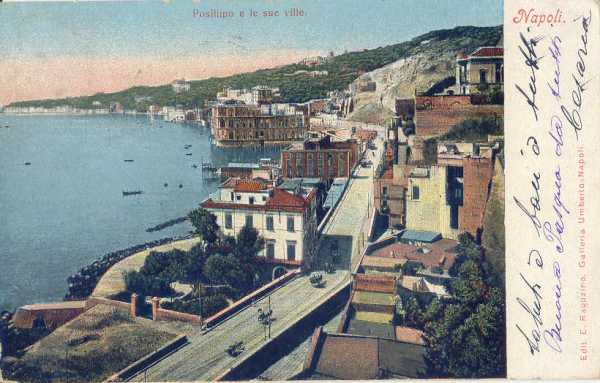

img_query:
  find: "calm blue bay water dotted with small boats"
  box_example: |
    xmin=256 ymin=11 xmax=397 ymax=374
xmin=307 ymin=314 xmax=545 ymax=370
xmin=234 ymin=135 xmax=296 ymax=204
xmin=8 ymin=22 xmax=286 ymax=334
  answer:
xmin=0 ymin=114 xmax=279 ymax=310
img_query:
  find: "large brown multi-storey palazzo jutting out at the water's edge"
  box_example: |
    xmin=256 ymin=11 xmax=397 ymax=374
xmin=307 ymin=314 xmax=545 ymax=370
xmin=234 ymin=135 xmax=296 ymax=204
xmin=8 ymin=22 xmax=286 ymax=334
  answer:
xmin=211 ymin=102 xmax=307 ymax=146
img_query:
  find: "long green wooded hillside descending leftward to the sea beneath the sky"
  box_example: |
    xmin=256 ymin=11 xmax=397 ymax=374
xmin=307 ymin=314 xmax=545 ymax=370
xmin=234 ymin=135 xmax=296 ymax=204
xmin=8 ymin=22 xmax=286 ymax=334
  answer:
xmin=9 ymin=26 xmax=502 ymax=111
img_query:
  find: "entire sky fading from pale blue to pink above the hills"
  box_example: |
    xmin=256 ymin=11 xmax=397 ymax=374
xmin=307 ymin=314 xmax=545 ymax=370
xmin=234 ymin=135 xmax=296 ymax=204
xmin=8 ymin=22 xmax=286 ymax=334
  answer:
xmin=0 ymin=0 xmax=502 ymax=104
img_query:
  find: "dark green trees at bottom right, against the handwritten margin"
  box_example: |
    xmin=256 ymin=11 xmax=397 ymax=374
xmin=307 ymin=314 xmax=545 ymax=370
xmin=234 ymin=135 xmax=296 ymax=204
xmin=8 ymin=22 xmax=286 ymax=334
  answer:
xmin=423 ymin=234 xmax=506 ymax=378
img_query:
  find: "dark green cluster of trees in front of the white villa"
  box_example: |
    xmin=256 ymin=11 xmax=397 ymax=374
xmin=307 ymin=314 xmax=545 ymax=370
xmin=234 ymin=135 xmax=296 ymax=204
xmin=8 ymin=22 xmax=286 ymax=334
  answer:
xmin=124 ymin=208 xmax=264 ymax=316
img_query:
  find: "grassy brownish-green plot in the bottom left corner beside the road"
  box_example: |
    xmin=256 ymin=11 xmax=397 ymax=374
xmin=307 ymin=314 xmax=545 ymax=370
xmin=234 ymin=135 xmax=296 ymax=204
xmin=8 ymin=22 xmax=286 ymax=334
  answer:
xmin=2 ymin=305 xmax=176 ymax=382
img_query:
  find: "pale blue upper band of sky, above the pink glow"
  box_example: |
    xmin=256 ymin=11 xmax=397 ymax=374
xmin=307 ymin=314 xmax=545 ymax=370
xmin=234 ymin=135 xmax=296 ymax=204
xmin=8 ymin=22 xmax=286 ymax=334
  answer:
xmin=0 ymin=0 xmax=502 ymax=57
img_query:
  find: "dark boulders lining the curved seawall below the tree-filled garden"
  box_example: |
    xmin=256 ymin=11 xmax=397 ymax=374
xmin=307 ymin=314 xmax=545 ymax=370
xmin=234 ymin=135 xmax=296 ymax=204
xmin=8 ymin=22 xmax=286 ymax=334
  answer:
xmin=64 ymin=234 xmax=192 ymax=301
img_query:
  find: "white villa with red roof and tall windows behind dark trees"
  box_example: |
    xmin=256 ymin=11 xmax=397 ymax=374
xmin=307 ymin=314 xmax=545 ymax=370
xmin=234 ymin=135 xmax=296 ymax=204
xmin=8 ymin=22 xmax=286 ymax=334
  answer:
xmin=200 ymin=178 xmax=317 ymax=266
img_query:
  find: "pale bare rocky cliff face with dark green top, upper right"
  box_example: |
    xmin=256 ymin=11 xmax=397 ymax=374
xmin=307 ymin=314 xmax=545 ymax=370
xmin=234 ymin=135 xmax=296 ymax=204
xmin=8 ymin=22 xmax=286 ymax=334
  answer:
xmin=349 ymin=27 xmax=502 ymax=123
